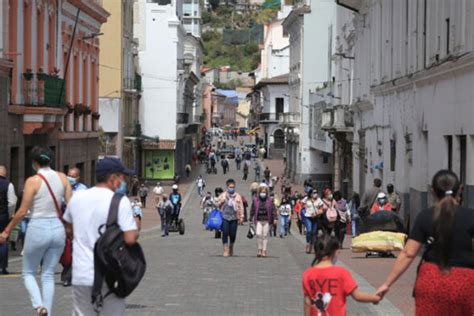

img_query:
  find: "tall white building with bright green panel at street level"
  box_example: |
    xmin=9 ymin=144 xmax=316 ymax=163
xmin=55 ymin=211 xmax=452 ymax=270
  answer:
xmin=134 ymin=0 xmax=198 ymax=179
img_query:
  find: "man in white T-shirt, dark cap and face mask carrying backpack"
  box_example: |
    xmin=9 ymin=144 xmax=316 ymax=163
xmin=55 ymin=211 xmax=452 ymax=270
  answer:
xmin=64 ymin=157 xmax=138 ymax=316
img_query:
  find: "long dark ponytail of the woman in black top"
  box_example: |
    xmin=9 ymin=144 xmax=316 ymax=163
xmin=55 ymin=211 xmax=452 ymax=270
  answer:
xmin=431 ymin=170 xmax=461 ymax=267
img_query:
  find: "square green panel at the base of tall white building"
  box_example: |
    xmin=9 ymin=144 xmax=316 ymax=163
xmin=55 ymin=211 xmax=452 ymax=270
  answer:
xmin=143 ymin=150 xmax=174 ymax=179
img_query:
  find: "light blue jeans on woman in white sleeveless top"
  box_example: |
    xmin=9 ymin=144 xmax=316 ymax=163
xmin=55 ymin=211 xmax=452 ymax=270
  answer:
xmin=23 ymin=218 xmax=66 ymax=315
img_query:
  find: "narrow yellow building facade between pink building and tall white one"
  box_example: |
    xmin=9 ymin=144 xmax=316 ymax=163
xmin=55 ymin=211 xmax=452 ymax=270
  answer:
xmin=99 ymin=0 xmax=141 ymax=170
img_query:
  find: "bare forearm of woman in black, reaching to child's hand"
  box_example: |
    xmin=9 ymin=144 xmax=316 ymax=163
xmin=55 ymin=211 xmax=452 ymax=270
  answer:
xmin=376 ymin=239 xmax=422 ymax=297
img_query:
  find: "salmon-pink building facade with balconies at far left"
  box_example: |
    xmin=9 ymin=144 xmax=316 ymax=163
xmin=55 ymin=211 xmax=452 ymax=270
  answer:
xmin=0 ymin=0 xmax=109 ymax=190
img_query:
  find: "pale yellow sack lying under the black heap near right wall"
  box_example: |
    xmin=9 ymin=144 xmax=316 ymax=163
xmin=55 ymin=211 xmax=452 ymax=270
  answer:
xmin=352 ymin=231 xmax=407 ymax=252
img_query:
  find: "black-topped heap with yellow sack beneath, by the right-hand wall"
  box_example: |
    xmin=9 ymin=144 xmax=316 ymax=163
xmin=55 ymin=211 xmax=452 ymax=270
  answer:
xmin=352 ymin=211 xmax=406 ymax=258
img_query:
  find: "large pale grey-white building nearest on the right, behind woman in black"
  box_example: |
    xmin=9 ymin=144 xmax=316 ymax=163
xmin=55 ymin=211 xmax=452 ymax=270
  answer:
xmin=339 ymin=0 xmax=474 ymax=219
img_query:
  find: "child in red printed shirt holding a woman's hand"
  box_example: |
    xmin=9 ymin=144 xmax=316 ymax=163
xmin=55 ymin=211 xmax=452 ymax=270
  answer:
xmin=303 ymin=235 xmax=381 ymax=316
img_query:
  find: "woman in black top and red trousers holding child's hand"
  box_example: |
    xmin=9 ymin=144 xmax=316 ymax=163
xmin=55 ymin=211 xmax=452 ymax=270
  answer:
xmin=377 ymin=170 xmax=474 ymax=316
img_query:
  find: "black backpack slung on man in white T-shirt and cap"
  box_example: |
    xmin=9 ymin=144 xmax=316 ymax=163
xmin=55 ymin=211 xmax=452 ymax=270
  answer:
xmin=92 ymin=193 xmax=146 ymax=312
